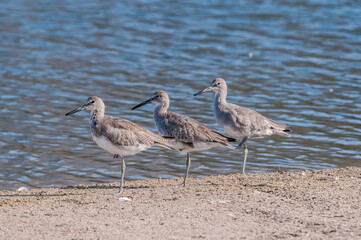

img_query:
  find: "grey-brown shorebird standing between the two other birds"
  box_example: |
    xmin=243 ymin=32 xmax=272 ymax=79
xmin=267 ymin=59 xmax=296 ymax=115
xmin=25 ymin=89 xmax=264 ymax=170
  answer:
xmin=132 ymin=91 xmax=236 ymax=186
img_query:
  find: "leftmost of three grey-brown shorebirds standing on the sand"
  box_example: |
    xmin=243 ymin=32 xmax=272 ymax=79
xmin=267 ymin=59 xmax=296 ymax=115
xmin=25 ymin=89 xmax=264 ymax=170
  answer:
xmin=65 ymin=96 xmax=169 ymax=193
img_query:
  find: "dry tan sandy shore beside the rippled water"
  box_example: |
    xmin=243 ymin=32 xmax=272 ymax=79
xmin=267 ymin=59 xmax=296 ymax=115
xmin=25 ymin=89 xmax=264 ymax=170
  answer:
xmin=0 ymin=168 xmax=361 ymax=239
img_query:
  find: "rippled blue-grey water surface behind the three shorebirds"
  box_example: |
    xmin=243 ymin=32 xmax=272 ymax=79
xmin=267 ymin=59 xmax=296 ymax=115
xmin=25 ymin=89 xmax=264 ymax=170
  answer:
xmin=0 ymin=0 xmax=361 ymax=189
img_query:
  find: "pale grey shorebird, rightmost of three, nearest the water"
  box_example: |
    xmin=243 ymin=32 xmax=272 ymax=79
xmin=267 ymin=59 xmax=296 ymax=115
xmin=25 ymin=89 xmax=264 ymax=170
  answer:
xmin=194 ymin=78 xmax=291 ymax=173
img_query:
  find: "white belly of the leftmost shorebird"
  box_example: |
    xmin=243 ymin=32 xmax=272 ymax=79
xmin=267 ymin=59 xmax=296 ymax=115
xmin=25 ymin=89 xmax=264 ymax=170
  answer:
xmin=93 ymin=135 xmax=150 ymax=156
